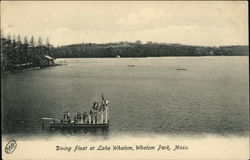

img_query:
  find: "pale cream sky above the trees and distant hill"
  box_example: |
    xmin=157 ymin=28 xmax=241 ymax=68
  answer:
xmin=1 ymin=1 xmax=249 ymax=46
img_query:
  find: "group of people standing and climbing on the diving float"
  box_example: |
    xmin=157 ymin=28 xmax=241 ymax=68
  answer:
xmin=61 ymin=94 xmax=109 ymax=124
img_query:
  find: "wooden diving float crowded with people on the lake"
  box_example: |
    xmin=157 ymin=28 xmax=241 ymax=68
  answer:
xmin=42 ymin=94 xmax=109 ymax=130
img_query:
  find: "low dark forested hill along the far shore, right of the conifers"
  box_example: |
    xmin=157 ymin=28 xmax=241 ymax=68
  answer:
xmin=51 ymin=41 xmax=249 ymax=58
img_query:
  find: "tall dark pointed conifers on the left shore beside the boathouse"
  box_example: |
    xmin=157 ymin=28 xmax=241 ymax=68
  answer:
xmin=1 ymin=35 xmax=53 ymax=71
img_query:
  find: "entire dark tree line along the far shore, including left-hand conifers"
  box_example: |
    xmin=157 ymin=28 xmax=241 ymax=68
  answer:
xmin=1 ymin=35 xmax=249 ymax=70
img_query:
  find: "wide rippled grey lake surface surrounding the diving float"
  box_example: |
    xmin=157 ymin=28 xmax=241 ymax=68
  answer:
xmin=1 ymin=56 xmax=249 ymax=137
